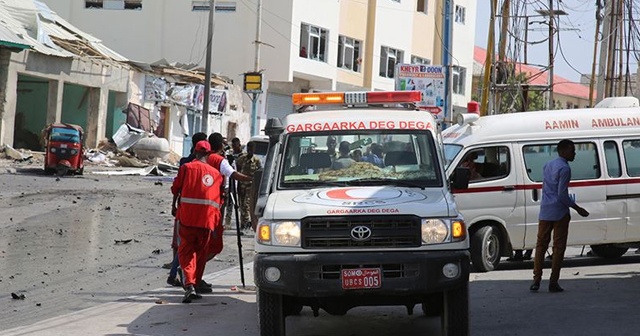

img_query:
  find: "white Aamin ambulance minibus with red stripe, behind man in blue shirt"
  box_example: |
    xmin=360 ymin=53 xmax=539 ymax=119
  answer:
xmin=442 ymin=99 xmax=640 ymax=271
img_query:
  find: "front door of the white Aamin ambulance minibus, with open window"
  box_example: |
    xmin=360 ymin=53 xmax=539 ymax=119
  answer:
xmin=454 ymin=144 xmax=524 ymax=246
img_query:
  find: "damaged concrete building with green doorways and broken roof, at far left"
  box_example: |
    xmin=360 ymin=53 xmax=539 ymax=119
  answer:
xmin=0 ymin=0 xmax=131 ymax=150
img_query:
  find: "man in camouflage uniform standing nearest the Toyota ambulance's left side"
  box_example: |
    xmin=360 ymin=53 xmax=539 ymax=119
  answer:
xmin=236 ymin=141 xmax=262 ymax=229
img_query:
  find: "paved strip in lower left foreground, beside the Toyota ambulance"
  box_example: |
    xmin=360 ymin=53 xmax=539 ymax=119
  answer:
xmin=0 ymin=263 xmax=257 ymax=336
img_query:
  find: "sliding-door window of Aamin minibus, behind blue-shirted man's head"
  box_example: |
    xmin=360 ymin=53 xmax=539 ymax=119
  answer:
xmin=522 ymin=142 xmax=600 ymax=182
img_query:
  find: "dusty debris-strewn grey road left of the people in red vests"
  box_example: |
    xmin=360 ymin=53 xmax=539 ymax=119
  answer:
xmin=0 ymin=160 xmax=253 ymax=329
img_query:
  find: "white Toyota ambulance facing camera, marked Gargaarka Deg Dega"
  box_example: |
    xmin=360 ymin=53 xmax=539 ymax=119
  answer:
xmin=254 ymin=91 xmax=469 ymax=336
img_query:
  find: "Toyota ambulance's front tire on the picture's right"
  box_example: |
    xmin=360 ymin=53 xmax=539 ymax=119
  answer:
xmin=440 ymin=282 xmax=469 ymax=336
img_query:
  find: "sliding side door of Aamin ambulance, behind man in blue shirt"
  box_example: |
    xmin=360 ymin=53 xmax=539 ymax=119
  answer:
xmin=522 ymin=141 xmax=607 ymax=247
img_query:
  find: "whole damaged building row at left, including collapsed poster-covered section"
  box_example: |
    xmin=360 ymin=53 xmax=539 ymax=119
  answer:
xmin=0 ymin=0 xmax=246 ymax=155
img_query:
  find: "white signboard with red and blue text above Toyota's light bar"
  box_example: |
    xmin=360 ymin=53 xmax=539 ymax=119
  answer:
xmin=395 ymin=64 xmax=445 ymax=119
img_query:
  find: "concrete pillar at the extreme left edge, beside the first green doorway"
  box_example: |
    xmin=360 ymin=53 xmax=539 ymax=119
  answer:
xmin=0 ymin=48 xmax=18 ymax=146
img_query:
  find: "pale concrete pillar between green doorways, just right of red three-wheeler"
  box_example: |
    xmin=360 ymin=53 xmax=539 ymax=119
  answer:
xmin=85 ymin=88 xmax=109 ymax=148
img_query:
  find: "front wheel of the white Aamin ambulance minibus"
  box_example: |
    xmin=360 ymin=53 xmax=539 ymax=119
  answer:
xmin=471 ymin=225 xmax=500 ymax=272
